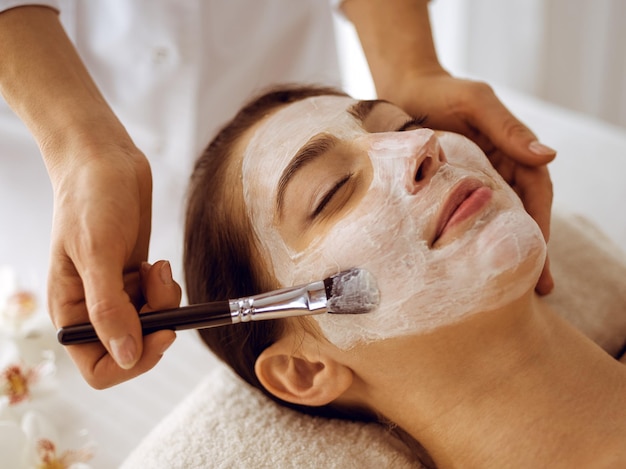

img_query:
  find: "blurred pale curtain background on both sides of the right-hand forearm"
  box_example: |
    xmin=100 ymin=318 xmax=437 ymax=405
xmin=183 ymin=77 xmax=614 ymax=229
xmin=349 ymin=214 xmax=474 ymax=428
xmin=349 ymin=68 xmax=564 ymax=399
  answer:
xmin=337 ymin=0 xmax=626 ymax=128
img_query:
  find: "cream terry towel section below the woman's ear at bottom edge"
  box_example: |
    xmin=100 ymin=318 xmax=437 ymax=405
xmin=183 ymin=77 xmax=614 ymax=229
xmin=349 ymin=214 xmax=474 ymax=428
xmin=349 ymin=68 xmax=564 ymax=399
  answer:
xmin=122 ymin=366 xmax=420 ymax=469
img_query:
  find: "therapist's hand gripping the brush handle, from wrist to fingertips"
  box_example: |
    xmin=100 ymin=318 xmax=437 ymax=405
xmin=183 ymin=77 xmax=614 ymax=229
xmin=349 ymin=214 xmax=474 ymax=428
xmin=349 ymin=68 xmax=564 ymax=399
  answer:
xmin=46 ymin=143 xmax=180 ymax=389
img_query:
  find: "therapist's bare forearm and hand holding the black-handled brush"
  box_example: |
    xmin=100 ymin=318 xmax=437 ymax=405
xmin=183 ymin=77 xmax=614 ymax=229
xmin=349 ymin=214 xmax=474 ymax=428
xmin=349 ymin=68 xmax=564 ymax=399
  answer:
xmin=0 ymin=6 xmax=181 ymax=388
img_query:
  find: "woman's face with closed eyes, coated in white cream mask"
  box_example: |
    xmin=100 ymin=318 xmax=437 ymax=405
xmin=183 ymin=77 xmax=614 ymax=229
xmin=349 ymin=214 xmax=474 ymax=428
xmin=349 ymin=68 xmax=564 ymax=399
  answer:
xmin=242 ymin=96 xmax=545 ymax=349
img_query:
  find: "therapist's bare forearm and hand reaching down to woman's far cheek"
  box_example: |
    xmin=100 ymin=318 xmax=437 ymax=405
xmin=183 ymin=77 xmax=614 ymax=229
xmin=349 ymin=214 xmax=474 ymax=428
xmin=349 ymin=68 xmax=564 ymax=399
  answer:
xmin=341 ymin=0 xmax=556 ymax=294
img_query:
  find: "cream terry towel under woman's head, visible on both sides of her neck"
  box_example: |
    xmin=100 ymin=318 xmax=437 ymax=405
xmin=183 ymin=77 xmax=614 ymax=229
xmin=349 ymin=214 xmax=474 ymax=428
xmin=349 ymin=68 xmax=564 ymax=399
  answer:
xmin=122 ymin=216 xmax=626 ymax=469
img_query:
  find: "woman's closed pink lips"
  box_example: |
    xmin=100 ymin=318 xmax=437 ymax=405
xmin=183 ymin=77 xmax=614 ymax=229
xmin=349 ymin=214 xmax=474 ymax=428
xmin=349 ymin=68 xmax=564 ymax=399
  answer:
xmin=431 ymin=179 xmax=492 ymax=246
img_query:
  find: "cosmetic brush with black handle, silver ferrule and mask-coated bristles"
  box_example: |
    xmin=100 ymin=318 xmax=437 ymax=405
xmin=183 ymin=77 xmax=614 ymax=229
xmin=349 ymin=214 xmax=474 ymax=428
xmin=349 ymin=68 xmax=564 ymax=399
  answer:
xmin=57 ymin=268 xmax=379 ymax=345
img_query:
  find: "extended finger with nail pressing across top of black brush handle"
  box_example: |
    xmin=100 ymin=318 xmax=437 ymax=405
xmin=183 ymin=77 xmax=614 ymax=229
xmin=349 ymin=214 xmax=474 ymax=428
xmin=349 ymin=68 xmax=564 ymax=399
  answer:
xmin=79 ymin=258 xmax=143 ymax=370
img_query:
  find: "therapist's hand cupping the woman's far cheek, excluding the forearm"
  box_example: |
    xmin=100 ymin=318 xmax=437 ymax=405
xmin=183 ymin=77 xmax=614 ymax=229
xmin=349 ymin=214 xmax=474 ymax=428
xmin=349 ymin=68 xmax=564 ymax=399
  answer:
xmin=386 ymin=70 xmax=556 ymax=294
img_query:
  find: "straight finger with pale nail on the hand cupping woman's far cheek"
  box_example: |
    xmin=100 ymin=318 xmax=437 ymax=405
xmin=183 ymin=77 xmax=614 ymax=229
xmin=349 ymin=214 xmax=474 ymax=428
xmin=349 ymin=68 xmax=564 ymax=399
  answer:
xmin=473 ymin=94 xmax=556 ymax=166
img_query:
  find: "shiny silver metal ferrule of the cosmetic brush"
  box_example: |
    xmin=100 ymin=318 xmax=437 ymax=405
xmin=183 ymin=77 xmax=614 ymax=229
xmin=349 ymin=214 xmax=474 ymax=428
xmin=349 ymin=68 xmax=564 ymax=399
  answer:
xmin=229 ymin=281 xmax=327 ymax=324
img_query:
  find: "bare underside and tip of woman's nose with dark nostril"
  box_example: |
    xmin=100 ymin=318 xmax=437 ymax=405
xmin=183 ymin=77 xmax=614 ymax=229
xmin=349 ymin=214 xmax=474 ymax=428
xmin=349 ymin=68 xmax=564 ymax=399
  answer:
xmin=404 ymin=129 xmax=446 ymax=195
